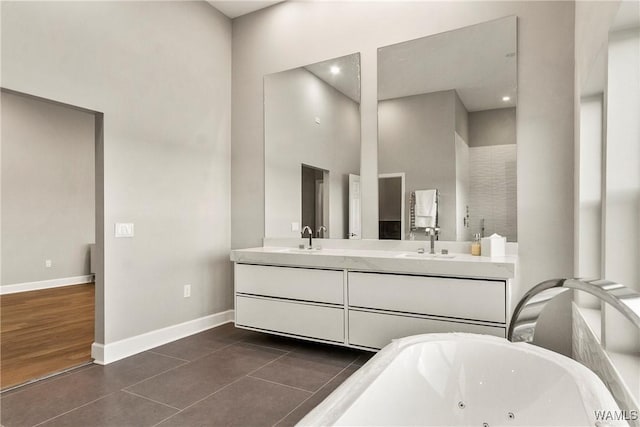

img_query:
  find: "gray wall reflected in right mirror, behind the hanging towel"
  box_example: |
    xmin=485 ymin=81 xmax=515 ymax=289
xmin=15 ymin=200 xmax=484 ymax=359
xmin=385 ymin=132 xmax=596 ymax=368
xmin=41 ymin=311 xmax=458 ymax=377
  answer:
xmin=378 ymin=90 xmax=456 ymax=240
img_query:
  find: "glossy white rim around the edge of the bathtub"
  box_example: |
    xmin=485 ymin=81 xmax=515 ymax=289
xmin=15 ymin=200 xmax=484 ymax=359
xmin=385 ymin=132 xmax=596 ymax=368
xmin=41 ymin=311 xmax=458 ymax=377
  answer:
xmin=297 ymin=332 xmax=619 ymax=426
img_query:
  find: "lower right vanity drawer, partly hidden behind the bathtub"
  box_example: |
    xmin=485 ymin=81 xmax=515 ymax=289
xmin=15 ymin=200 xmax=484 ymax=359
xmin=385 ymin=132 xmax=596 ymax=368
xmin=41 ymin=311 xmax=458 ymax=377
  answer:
xmin=349 ymin=310 xmax=506 ymax=348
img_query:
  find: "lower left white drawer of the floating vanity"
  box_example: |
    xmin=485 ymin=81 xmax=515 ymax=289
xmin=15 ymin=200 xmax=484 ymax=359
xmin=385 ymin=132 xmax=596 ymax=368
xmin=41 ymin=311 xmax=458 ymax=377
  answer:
xmin=236 ymin=295 xmax=344 ymax=343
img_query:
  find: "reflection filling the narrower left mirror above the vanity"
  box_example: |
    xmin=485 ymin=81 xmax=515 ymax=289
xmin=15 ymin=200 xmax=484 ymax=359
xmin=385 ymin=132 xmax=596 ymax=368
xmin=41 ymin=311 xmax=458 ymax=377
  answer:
xmin=264 ymin=54 xmax=360 ymax=239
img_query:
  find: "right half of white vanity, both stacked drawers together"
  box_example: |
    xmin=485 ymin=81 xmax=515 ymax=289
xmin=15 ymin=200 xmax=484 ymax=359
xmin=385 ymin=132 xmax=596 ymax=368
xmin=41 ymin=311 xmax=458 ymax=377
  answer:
xmin=348 ymin=272 xmax=508 ymax=348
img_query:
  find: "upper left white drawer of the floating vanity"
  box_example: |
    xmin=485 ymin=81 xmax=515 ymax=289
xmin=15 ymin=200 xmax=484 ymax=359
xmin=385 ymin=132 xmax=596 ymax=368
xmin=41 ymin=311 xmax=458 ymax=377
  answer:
xmin=234 ymin=264 xmax=344 ymax=304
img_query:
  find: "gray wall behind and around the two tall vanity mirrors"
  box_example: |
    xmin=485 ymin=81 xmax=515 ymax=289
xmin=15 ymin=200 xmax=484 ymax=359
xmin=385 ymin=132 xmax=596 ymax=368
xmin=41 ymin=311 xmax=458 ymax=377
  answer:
xmin=231 ymin=1 xmax=574 ymax=352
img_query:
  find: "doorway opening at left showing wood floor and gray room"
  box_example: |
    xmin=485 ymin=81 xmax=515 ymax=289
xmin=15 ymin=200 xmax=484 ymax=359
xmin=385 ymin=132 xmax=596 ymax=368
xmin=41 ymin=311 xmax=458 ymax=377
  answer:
xmin=0 ymin=88 xmax=104 ymax=391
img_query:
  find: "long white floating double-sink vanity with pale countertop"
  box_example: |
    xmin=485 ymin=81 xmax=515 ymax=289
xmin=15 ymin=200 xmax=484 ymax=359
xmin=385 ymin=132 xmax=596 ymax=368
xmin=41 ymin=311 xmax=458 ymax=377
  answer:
xmin=231 ymin=247 xmax=517 ymax=350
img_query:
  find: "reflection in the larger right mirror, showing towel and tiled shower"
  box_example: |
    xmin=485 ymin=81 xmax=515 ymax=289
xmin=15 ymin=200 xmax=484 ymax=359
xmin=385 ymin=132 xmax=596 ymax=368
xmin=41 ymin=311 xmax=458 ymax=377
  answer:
xmin=378 ymin=16 xmax=517 ymax=241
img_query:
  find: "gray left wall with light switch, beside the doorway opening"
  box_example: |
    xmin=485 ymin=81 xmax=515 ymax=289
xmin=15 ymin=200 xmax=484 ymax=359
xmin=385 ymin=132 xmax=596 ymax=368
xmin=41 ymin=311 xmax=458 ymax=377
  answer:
xmin=1 ymin=2 xmax=232 ymax=344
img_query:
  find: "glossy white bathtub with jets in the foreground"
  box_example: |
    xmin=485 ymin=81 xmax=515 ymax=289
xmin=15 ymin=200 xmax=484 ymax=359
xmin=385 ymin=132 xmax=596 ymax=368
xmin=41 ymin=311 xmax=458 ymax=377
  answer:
xmin=298 ymin=333 xmax=626 ymax=426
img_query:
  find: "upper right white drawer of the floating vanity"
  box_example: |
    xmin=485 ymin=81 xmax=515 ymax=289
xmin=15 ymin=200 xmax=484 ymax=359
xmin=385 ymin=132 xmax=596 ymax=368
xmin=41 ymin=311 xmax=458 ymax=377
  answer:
xmin=348 ymin=272 xmax=506 ymax=323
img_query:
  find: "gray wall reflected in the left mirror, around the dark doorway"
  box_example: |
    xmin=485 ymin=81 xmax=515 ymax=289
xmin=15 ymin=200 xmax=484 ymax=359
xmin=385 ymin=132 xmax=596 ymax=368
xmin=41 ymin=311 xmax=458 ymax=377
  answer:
xmin=262 ymin=68 xmax=360 ymax=239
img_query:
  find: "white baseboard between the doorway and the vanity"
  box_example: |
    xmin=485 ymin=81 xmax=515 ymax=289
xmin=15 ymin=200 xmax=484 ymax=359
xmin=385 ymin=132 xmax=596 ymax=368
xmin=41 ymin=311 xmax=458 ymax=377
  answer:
xmin=91 ymin=310 xmax=234 ymax=365
